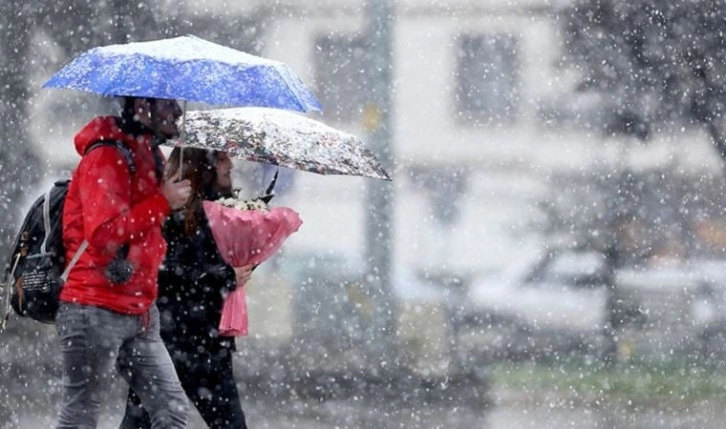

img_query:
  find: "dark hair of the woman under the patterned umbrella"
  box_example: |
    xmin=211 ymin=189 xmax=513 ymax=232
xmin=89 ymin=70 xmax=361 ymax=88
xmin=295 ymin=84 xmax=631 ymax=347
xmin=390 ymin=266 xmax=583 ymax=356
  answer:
xmin=165 ymin=147 xmax=231 ymax=235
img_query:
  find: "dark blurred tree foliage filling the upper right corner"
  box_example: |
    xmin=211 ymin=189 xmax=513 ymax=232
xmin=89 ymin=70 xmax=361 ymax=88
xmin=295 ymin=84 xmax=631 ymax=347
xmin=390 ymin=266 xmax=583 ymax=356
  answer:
xmin=561 ymin=0 xmax=726 ymax=162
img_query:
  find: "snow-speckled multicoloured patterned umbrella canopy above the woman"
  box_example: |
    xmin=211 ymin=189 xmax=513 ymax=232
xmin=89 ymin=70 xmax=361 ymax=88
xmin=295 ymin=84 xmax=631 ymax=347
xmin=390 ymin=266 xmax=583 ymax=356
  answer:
xmin=167 ymin=107 xmax=391 ymax=180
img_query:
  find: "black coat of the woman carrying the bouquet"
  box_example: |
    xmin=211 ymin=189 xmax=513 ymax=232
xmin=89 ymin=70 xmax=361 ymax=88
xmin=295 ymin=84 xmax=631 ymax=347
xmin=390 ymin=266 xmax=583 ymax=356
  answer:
xmin=157 ymin=201 xmax=236 ymax=357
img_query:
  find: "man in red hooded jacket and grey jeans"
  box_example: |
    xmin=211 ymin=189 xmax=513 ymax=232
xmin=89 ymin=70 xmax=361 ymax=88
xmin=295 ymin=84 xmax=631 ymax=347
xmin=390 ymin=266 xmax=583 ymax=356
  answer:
xmin=56 ymin=97 xmax=191 ymax=428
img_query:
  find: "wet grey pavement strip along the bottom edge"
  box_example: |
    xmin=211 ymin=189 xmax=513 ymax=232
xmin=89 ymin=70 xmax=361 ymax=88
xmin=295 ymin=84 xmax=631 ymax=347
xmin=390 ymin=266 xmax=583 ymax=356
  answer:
xmin=12 ymin=387 xmax=726 ymax=429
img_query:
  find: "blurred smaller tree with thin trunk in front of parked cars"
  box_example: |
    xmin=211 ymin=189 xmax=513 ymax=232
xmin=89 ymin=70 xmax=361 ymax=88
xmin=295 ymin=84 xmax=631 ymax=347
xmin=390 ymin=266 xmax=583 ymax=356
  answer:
xmin=536 ymin=163 xmax=726 ymax=367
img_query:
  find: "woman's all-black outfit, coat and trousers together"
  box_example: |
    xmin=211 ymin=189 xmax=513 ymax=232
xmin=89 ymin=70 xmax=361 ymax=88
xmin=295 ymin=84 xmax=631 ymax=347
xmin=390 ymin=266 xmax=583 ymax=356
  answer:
xmin=120 ymin=194 xmax=247 ymax=429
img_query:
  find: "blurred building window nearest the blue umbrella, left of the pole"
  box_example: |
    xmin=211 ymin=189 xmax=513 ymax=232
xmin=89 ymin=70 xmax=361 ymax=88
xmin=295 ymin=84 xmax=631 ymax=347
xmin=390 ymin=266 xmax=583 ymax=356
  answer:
xmin=314 ymin=34 xmax=366 ymax=122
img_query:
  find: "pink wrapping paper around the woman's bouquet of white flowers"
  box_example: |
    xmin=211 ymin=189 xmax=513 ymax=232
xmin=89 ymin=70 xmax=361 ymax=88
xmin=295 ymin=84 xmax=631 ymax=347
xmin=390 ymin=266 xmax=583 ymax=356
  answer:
xmin=203 ymin=201 xmax=302 ymax=336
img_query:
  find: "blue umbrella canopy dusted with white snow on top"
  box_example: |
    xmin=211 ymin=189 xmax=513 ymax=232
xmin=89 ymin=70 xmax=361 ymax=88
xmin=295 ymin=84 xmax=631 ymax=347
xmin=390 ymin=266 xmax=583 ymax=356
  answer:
xmin=43 ymin=36 xmax=321 ymax=112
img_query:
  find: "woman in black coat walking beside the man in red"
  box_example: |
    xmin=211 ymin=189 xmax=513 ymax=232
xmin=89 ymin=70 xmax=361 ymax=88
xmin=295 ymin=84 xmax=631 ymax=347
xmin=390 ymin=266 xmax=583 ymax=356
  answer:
xmin=121 ymin=148 xmax=252 ymax=429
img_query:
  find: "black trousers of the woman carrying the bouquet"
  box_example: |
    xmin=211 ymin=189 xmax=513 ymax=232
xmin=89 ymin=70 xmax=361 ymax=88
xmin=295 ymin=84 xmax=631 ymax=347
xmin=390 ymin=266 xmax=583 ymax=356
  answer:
xmin=120 ymin=343 xmax=247 ymax=429
